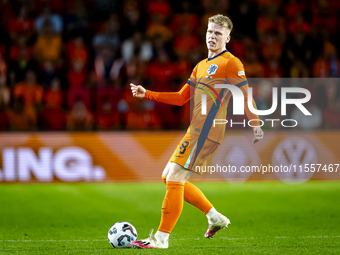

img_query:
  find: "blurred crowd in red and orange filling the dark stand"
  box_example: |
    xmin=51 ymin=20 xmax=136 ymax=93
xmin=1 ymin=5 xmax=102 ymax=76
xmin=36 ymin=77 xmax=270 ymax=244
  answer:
xmin=0 ymin=0 xmax=340 ymax=131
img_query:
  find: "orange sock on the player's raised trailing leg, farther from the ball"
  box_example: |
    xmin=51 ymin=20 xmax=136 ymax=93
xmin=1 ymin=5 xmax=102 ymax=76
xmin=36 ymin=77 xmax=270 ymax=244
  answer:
xmin=162 ymin=176 xmax=213 ymax=214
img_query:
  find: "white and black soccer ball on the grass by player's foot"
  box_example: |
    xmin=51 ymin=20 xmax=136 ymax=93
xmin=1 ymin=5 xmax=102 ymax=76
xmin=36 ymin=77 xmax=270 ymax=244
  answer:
xmin=108 ymin=221 xmax=137 ymax=248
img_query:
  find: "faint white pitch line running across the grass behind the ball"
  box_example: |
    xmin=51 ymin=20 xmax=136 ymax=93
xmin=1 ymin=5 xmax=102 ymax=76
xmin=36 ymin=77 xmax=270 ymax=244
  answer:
xmin=0 ymin=235 xmax=340 ymax=243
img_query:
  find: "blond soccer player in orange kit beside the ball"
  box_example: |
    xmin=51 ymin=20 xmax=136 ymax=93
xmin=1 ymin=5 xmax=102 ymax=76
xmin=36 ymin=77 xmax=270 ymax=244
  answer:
xmin=130 ymin=14 xmax=263 ymax=249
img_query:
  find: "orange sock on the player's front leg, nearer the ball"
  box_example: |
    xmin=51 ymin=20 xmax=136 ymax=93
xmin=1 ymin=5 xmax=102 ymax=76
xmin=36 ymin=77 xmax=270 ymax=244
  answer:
xmin=158 ymin=181 xmax=184 ymax=234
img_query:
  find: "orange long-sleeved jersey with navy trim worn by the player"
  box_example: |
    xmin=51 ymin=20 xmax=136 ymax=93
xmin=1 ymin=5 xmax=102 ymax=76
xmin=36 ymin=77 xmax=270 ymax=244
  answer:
xmin=145 ymin=50 xmax=259 ymax=143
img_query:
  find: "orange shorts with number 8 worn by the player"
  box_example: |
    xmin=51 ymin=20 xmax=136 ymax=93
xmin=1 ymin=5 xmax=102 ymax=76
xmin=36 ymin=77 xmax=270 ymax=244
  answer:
xmin=169 ymin=131 xmax=220 ymax=173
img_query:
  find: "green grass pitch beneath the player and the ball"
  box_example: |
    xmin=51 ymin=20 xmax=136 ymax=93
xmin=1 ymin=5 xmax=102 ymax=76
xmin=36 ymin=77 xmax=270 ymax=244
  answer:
xmin=0 ymin=181 xmax=340 ymax=254
